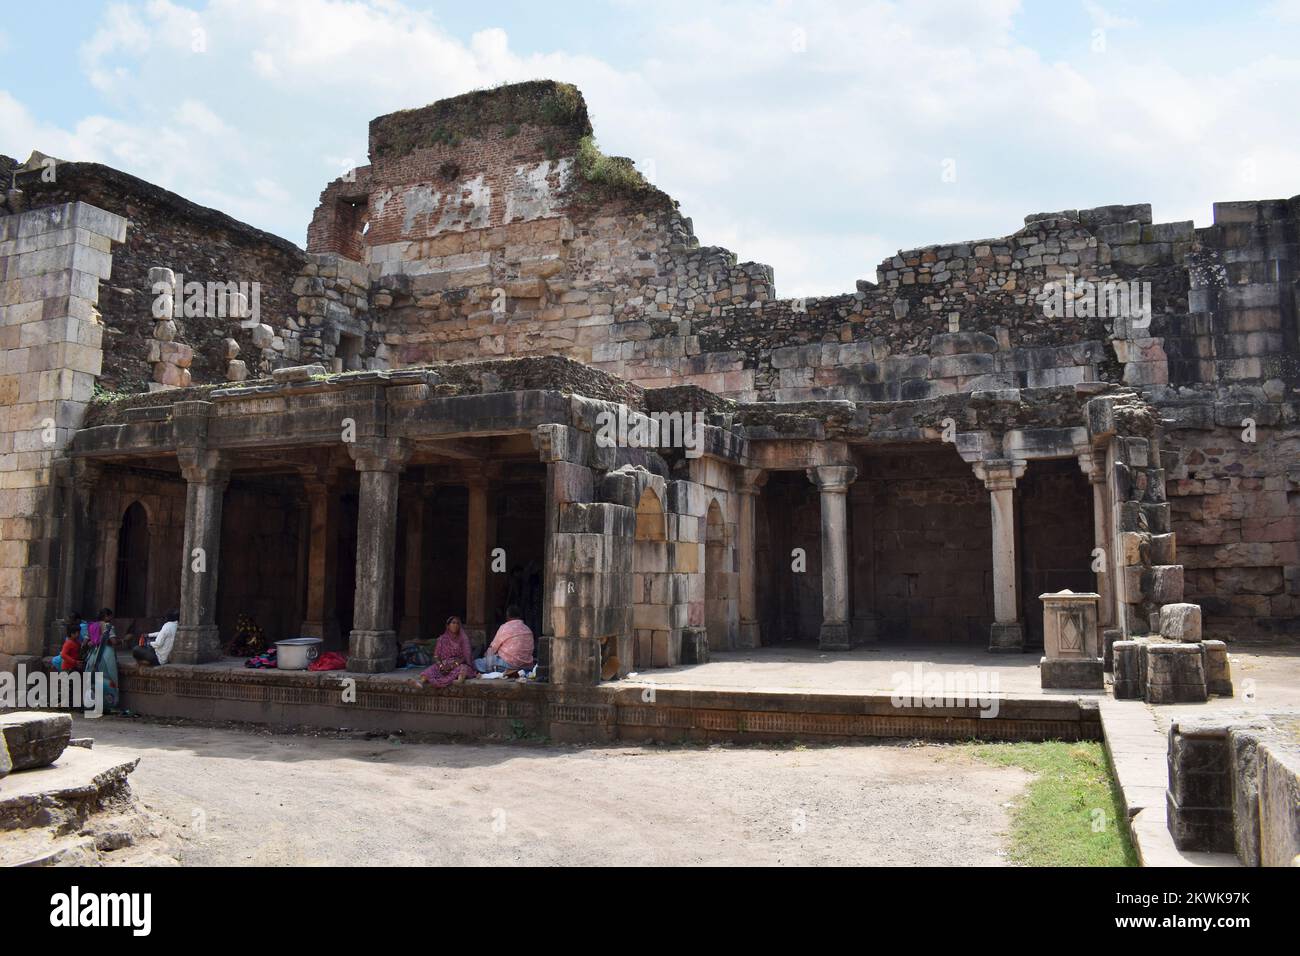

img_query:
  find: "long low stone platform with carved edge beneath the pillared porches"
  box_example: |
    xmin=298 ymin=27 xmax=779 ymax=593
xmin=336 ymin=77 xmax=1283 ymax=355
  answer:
xmin=121 ymin=649 xmax=1101 ymax=743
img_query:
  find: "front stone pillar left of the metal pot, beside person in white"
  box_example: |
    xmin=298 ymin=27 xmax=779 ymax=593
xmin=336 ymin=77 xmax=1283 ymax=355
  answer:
xmin=170 ymin=449 xmax=230 ymax=663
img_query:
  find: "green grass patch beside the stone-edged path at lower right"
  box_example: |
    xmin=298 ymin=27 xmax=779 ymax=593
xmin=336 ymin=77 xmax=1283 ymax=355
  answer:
xmin=962 ymin=740 xmax=1138 ymax=866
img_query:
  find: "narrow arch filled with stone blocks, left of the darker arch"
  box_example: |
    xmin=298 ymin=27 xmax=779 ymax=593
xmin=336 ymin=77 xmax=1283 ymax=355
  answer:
xmin=632 ymin=488 xmax=676 ymax=669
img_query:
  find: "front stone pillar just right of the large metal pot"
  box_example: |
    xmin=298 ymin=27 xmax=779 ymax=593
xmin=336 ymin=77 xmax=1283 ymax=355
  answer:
xmin=347 ymin=438 xmax=410 ymax=674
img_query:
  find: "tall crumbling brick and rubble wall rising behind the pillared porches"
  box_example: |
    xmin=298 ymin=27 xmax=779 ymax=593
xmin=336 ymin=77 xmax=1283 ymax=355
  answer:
xmin=2 ymin=85 xmax=1300 ymax=650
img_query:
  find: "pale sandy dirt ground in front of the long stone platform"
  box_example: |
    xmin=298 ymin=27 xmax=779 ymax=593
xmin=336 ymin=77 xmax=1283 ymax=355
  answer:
xmin=75 ymin=718 xmax=1031 ymax=866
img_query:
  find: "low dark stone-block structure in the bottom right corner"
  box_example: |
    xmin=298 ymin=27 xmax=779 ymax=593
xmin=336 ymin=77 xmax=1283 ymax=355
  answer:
xmin=1166 ymin=717 xmax=1300 ymax=866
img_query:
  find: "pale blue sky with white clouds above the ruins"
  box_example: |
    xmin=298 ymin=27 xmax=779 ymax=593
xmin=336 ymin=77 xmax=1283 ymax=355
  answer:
xmin=0 ymin=0 xmax=1300 ymax=295
